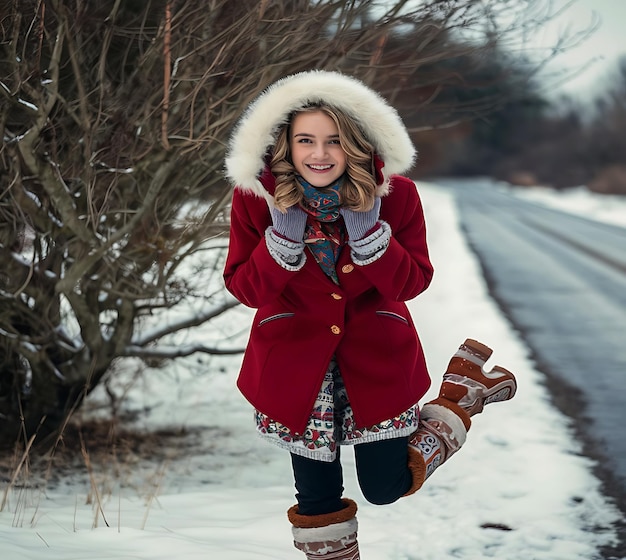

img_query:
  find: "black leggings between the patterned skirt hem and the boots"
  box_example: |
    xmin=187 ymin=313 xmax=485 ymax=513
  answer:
xmin=291 ymin=437 xmax=413 ymax=515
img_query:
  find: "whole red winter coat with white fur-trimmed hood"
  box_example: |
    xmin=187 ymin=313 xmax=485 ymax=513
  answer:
xmin=224 ymin=71 xmax=433 ymax=433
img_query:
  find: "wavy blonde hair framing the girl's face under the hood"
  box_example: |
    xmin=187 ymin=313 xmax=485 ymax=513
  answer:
xmin=270 ymin=104 xmax=377 ymax=212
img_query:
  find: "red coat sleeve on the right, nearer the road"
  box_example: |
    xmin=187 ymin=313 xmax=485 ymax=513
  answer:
xmin=360 ymin=176 xmax=433 ymax=301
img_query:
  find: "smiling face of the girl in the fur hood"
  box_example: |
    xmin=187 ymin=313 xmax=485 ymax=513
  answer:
xmin=289 ymin=111 xmax=346 ymax=188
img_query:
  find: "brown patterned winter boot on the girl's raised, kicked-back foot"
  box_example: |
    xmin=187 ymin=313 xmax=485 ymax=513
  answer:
xmin=407 ymin=338 xmax=517 ymax=495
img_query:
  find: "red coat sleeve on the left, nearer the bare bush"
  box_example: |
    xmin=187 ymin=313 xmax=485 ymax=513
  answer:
xmin=224 ymin=188 xmax=298 ymax=308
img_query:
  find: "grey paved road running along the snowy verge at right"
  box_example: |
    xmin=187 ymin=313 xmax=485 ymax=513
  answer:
xmin=438 ymin=180 xmax=626 ymax=514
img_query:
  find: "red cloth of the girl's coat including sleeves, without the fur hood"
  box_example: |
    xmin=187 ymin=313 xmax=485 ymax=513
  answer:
xmin=224 ymin=176 xmax=433 ymax=433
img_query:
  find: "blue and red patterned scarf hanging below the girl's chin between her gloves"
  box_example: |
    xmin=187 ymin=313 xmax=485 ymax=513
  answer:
xmin=298 ymin=176 xmax=346 ymax=284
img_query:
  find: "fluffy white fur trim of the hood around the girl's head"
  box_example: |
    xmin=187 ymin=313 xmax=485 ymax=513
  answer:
xmin=226 ymin=70 xmax=416 ymax=197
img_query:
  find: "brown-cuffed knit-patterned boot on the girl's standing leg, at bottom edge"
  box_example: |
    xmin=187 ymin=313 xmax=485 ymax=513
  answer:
xmin=287 ymin=498 xmax=360 ymax=560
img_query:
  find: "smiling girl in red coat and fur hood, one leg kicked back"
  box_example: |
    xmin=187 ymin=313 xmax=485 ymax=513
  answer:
xmin=224 ymin=71 xmax=516 ymax=560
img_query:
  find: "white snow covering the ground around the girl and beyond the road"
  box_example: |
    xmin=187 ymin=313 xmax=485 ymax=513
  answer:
xmin=0 ymin=184 xmax=626 ymax=560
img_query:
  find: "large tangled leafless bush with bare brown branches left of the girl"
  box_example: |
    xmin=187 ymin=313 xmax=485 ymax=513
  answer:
xmin=0 ymin=0 xmax=576 ymax=443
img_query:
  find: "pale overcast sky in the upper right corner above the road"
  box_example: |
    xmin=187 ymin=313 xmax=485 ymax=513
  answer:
xmin=529 ymin=0 xmax=626 ymax=100
